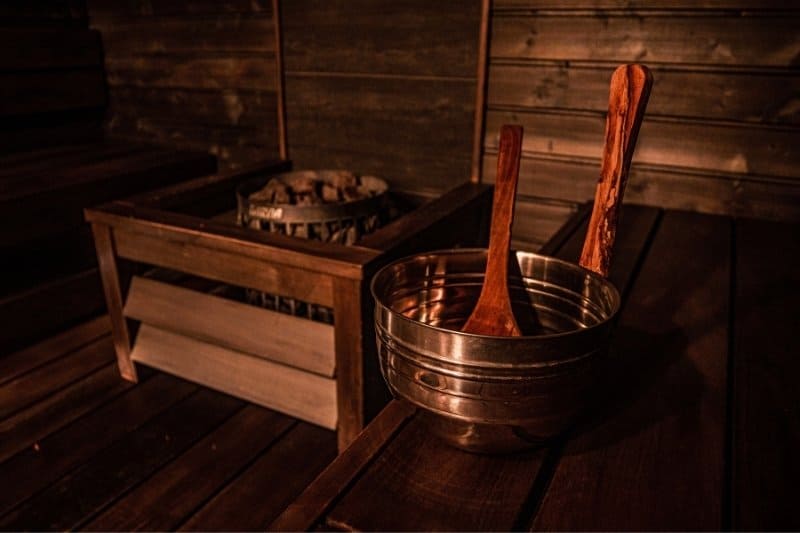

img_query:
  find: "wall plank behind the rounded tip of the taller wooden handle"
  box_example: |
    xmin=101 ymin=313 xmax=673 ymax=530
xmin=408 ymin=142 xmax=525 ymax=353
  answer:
xmin=489 ymin=61 xmax=800 ymax=124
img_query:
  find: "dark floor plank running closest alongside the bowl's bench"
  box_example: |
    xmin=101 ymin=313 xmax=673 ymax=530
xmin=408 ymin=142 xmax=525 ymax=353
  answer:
xmin=179 ymin=422 xmax=336 ymax=531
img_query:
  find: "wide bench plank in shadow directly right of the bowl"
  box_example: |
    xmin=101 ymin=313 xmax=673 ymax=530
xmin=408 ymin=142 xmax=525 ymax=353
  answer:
xmin=533 ymin=212 xmax=731 ymax=530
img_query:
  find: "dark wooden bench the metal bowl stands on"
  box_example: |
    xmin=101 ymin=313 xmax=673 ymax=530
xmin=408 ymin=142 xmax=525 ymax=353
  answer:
xmin=270 ymin=206 xmax=800 ymax=531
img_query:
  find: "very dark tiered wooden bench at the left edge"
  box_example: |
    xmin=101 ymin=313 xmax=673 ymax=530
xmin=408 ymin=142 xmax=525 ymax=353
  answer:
xmin=0 ymin=27 xmax=216 ymax=353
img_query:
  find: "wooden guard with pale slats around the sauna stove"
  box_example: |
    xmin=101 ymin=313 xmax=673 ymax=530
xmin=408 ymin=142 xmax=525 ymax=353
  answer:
xmin=85 ymin=161 xmax=492 ymax=449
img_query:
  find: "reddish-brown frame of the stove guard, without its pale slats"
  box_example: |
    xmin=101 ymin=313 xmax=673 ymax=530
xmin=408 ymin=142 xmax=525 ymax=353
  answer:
xmin=85 ymin=161 xmax=491 ymax=449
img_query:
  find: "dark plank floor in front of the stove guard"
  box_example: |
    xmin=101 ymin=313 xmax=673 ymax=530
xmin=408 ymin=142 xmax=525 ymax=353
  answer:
xmin=0 ymin=317 xmax=336 ymax=530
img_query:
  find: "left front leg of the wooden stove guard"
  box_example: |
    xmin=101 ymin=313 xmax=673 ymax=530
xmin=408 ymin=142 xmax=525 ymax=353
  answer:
xmin=92 ymin=223 xmax=138 ymax=383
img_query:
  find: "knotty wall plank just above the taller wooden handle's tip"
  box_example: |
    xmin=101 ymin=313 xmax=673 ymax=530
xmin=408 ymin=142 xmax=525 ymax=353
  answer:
xmin=490 ymin=12 xmax=800 ymax=67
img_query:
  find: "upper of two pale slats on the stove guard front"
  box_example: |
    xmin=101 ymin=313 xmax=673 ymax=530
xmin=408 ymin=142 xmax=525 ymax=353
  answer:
xmin=125 ymin=276 xmax=336 ymax=377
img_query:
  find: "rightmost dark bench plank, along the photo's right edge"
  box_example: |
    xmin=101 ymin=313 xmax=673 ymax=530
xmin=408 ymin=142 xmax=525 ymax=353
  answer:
xmin=730 ymin=219 xmax=800 ymax=530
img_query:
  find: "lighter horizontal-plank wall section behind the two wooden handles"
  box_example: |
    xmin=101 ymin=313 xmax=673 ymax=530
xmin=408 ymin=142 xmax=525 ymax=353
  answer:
xmin=484 ymin=0 xmax=800 ymax=248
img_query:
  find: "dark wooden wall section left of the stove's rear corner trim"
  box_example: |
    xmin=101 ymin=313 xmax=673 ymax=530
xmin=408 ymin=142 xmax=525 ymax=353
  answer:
xmin=88 ymin=0 xmax=279 ymax=168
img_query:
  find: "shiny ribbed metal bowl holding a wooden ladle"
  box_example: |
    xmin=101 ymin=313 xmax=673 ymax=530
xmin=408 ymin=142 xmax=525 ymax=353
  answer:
xmin=371 ymin=249 xmax=620 ymax=453
